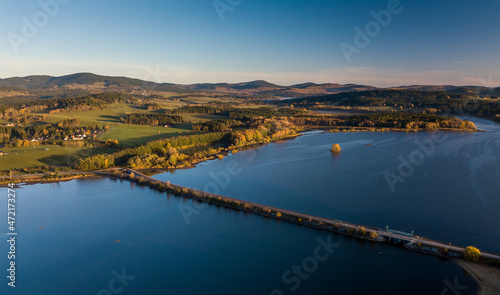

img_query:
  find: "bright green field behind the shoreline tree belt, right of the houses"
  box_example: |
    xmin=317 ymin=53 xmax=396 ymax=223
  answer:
xmin=97 ymin=124 xmax=191 ymax=147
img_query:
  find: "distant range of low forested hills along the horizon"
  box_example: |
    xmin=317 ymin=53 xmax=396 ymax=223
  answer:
xmin=0 ymin=73 xmax=500 ymax=98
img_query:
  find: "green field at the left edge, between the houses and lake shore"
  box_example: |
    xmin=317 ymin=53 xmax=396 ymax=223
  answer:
xmin=0 ymin=145 xmax=115 ymax=171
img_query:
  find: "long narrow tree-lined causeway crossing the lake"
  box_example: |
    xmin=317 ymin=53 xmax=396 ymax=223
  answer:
xmin=94 ymin=168 xmax=500 ymax=267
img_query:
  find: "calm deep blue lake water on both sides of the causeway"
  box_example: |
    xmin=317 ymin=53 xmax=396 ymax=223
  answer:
xmin=0 ymin=119 xmax=500 ymax=295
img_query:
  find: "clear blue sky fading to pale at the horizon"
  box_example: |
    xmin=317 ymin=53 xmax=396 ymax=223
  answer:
xmin=0 ymin=0 xmax=500 ymax=86
